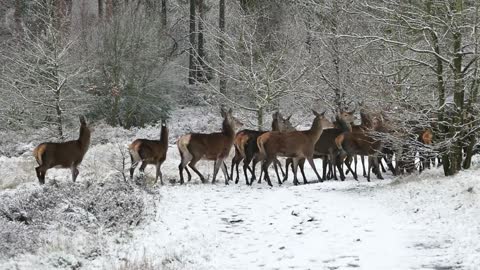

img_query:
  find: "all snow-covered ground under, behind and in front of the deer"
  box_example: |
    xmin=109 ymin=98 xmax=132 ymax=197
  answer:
xmin=0 ymin=107 xmax=480 ymax=270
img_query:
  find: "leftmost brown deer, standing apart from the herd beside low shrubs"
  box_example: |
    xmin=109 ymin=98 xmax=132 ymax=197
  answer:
xmin=33 ymin=116 xmax=91 ymax=185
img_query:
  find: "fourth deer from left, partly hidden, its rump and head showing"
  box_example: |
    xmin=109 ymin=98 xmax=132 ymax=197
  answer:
xmin=230 ymin=112 xmax=295 ymax=185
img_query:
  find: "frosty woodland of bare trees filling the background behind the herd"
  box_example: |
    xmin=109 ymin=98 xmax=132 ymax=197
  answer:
xmin=0 ymin=0 xmax=479 ymax=175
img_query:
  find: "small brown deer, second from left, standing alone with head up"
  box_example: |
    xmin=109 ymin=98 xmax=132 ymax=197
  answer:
xmin=128 ymin=119 xmax=168 ymax=185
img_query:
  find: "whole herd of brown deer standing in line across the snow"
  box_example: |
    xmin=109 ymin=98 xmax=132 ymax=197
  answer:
xmin=33 ymin=108 xmax=433 ymax=186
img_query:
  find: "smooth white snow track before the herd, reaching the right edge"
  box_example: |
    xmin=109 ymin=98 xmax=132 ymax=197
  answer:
xmin=92 ymin=165 xmax=480 ymax=269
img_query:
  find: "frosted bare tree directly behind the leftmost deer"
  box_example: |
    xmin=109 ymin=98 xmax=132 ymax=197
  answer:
xmin=0 ymin=0 xmax=91 ymax=139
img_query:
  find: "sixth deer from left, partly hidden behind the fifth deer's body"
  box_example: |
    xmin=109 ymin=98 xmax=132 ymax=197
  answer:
xmin=283 ymin=110 xmax=355 ymax=182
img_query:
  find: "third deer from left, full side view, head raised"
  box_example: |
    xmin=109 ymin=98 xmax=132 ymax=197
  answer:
xmin=177 ymin=107 xmax=243 ymax=185
